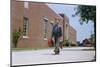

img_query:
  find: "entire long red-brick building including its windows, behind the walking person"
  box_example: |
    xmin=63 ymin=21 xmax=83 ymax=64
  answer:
xmin=11 ymin=0 xmax=76 ymax=48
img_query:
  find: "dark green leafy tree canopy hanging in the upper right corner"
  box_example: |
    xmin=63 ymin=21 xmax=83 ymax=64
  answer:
xmin=73 ymin=5 xmax=96 ymax=24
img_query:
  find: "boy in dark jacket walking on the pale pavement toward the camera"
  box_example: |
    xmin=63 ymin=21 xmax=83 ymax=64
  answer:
xmin=52 ymin=18 xmax=62 ymax=54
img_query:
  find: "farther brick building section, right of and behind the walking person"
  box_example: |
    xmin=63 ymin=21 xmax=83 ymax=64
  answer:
xmin=60 ymin=14 xmax=77 ymax=44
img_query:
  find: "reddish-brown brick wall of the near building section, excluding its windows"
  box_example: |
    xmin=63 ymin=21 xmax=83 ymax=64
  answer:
xmin=11 ymin=0 xmax=62 ymax=48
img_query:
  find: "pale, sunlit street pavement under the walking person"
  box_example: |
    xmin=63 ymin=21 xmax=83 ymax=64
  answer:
xmin=12 ymin=47 xmax=95 ymax=65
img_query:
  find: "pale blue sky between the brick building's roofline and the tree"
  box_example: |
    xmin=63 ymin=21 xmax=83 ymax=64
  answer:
xmin=48 ymin=4 xmax=94 ymax=42
